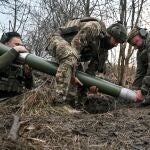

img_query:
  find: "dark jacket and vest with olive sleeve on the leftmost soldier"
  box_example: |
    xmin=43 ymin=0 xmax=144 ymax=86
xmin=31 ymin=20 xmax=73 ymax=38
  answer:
xmin=0 ymin=49 xmax=33 ymax=93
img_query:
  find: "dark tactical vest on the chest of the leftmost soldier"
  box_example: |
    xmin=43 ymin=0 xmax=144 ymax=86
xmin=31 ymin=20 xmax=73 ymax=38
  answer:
xmin=0 ymin=64 xmax=23 ymax=93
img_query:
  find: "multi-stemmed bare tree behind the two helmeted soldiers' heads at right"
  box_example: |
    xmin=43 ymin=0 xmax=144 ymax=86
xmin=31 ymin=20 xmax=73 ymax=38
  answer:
xmin=118 ymin=0 xmax=146 ymax=85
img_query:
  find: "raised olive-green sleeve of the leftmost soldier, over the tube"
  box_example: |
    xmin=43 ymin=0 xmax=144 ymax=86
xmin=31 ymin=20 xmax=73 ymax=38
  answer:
xmin=0 ymin=49 xmax=19 ymax=71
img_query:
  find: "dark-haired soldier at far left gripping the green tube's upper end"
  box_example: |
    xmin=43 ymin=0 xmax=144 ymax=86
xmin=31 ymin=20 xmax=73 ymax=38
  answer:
xmin=0 ymin=32 xmax=33 ymax=100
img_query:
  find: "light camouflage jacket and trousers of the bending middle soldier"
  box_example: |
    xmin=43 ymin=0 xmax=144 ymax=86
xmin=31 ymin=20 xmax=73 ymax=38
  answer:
xmin=48 ymin=20 xmax=107 ymax=102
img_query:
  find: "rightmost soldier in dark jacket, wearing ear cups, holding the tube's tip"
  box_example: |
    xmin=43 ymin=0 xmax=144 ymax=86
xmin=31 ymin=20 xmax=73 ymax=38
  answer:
xmin=128 ymin=27 xmax=150 ymax=105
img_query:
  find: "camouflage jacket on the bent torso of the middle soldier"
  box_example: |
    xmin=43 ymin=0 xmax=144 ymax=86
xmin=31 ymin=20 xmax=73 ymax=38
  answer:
xmin=59 ymin=19 xmax=108 ymax=75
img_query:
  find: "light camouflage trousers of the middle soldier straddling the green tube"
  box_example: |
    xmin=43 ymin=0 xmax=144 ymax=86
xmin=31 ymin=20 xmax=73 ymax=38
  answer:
xmin=48 ymin=35 xmax=78 ymax=103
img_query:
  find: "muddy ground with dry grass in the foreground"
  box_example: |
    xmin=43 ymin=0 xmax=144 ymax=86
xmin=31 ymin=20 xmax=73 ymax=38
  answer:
xmin=0 ymin=86 xmax=150 ymax=150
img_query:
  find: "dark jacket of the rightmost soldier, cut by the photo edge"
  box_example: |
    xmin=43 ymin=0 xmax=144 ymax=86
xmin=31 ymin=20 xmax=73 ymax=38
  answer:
xmin=133 ymin=33 xmax=150 ymax=95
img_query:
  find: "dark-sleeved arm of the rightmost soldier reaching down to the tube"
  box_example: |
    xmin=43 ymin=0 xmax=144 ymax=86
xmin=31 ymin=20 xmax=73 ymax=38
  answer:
xmin=132 ymin=53 xmax=147 ymax=90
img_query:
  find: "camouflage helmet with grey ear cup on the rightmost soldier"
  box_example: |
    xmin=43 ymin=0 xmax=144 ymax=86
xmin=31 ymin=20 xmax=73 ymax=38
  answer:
xmin=127 ymin=27 xmax=148 ymax=44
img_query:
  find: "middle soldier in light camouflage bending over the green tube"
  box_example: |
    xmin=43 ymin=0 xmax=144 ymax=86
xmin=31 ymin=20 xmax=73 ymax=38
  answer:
xmin=48 ymin=17 xmax=127 ymax=108
